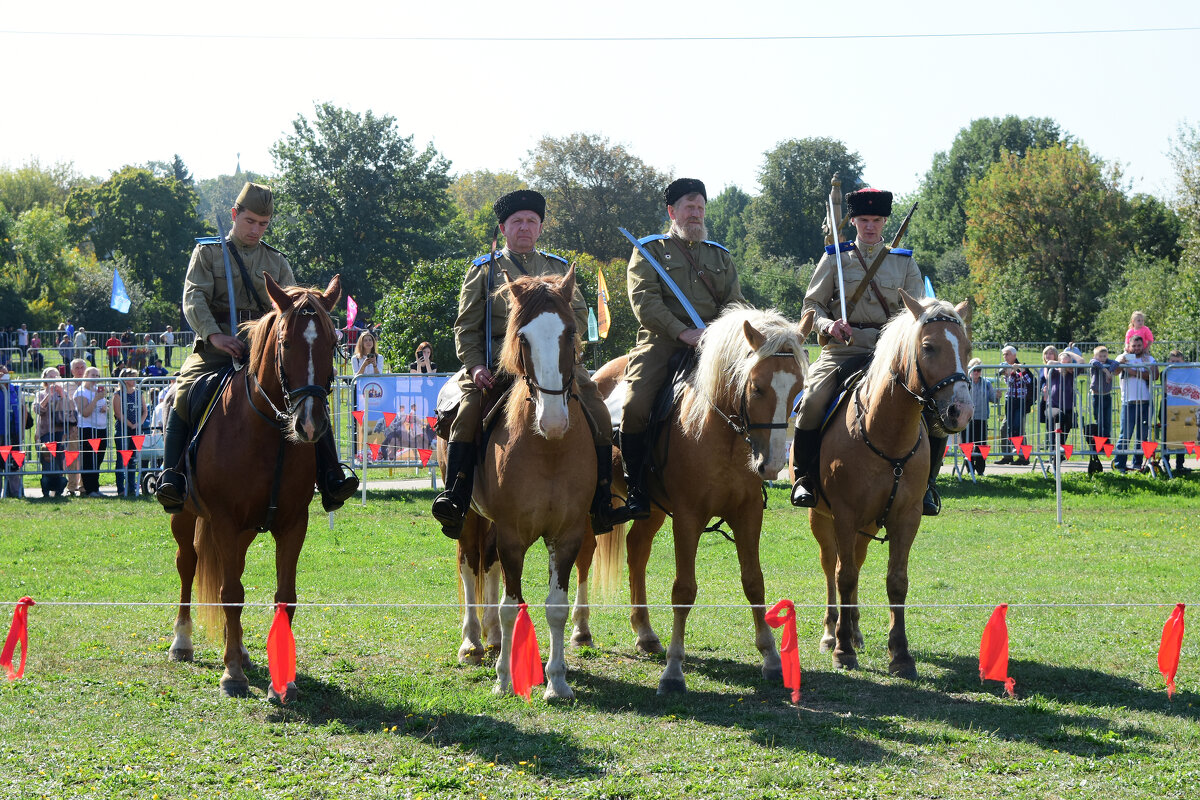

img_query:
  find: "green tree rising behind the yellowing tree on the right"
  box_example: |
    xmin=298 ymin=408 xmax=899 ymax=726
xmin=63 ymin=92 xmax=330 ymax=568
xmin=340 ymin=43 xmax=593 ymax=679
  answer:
xmin=905 ymin=115 xmax=1070 ymax=265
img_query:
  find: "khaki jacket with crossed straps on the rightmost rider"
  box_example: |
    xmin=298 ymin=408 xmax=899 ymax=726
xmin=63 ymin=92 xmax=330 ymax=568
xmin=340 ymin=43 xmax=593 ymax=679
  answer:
xmin=804 ymin=240 xmax=925 ymax=349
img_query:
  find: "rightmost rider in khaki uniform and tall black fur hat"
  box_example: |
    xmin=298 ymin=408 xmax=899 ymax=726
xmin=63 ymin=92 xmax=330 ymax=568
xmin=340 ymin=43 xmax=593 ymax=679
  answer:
xmin=792 ymin=188 xmax=946 ymax=516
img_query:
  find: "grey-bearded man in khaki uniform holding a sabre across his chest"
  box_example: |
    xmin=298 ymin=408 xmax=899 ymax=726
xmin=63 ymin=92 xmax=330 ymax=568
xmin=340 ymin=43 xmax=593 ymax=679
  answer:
xmin=620 ymin=178 xmax=745 ymax=519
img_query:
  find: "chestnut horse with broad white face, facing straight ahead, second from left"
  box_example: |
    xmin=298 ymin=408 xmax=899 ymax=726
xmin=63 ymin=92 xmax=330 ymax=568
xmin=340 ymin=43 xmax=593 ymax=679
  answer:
xmin=438 ymin=266 xmax=596 ymax=699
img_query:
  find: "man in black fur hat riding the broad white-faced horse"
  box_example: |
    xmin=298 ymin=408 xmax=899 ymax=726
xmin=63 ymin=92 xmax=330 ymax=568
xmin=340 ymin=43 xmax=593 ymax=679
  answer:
xmin=433 ymin=190 xmax=630 ymax=539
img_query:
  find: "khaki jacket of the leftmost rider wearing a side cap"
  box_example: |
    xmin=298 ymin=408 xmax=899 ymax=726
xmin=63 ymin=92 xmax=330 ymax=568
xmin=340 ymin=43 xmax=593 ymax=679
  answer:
xmin=184 ymin=235 xmax=296 ymax=342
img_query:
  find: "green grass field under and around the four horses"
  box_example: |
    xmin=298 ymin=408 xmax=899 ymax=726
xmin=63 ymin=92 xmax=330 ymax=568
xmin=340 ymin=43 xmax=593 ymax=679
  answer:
xmin=0 ymin=473 xmax=1200 ymax=800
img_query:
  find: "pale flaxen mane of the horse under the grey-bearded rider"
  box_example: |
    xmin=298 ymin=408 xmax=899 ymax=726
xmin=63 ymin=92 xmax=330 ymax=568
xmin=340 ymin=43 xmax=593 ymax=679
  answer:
xmin=682 ymin=305 xmax=809 ymax=437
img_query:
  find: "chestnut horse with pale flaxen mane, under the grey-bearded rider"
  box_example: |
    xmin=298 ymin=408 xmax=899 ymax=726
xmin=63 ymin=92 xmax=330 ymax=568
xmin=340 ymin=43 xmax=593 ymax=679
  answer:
xmin=572 ymin=306 xmax=808 ymax=694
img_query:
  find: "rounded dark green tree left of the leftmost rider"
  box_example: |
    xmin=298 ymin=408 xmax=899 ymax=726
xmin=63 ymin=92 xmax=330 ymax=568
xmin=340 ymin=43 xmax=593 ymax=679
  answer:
xmin=66 ymin=167 xmax=208 ymax=297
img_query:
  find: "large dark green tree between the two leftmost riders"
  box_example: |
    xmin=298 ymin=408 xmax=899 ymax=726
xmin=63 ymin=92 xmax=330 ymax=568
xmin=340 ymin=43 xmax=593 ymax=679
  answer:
xmin=271 ymin=103 xmax=454 ymax=308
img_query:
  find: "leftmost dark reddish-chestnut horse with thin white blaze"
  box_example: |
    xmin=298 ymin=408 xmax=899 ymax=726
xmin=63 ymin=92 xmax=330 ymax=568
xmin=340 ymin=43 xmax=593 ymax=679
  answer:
xmin=169 ymin=275 xmax=342 ymax=699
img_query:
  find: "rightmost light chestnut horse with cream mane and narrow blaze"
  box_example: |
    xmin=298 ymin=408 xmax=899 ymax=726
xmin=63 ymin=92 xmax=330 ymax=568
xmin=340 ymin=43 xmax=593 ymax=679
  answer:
xmin=809 ymin=289 xmax=973 ymax=679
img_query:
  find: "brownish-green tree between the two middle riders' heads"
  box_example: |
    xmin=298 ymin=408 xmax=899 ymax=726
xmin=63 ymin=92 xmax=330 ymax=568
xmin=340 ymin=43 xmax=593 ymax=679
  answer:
xmin=522 ymin=133 xmax=671 ymax=260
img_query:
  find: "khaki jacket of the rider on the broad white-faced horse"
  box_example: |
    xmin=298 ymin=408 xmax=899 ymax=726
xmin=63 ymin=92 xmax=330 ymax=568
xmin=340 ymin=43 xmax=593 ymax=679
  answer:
xmin=454 ymin=247 xmax=588 ymax=369
